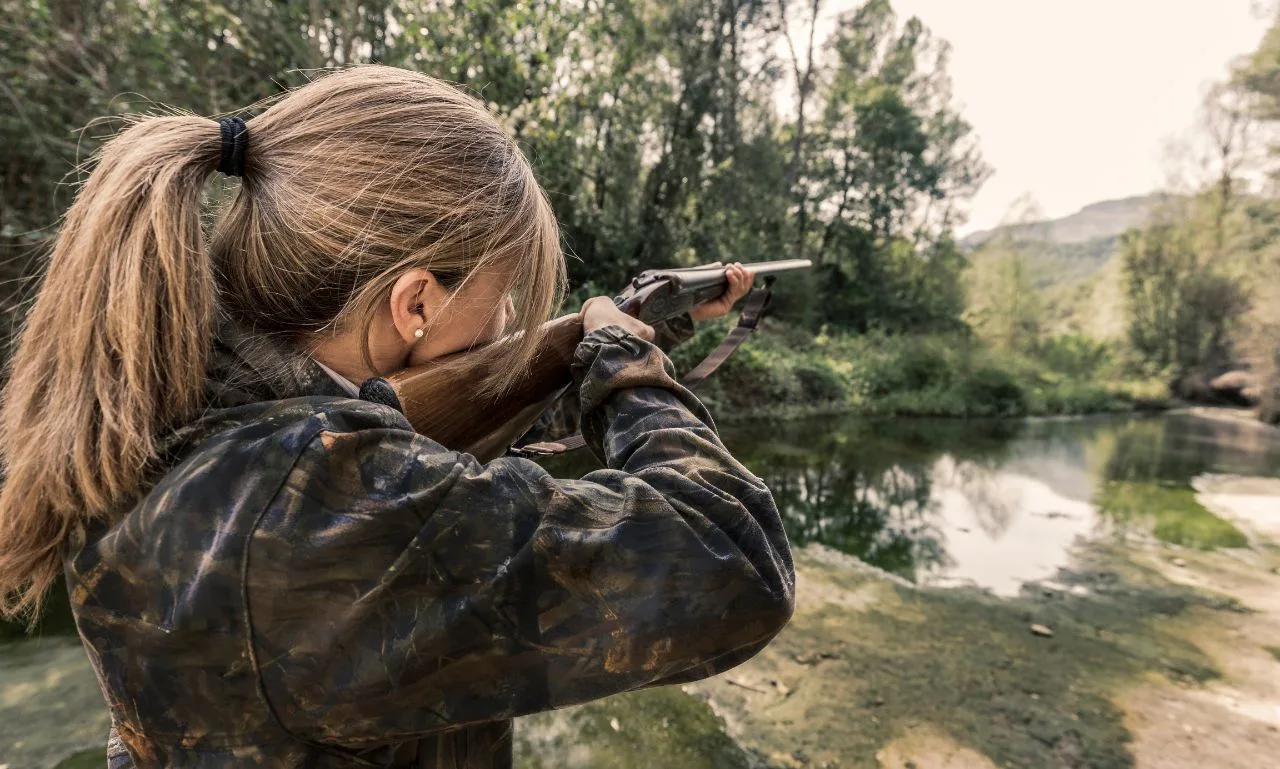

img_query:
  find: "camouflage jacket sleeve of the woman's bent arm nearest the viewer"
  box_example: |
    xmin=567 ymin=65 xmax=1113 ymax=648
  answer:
xmin=244 ymin=326 xmax=795 ymax=746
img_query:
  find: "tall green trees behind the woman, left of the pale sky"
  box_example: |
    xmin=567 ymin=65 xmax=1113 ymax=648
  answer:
xmin=0 ymin=0 xmax=987 ymax=348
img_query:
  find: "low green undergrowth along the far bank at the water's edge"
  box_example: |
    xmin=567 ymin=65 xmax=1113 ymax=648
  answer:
xmin=672 ymin=321 xmax=1174 ymax=422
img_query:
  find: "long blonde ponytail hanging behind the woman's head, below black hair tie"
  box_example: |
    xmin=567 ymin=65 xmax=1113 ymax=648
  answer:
xmin=0 ymin=116 xmax=221 ymax=617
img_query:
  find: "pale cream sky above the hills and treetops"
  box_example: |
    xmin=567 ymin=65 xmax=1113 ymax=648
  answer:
xmin=808 ymin=0 xmax=1272 ymax=234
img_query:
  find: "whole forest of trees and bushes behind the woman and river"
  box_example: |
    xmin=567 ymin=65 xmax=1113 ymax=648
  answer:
xmin=0 ymin=0 xmax=1280 ymax=421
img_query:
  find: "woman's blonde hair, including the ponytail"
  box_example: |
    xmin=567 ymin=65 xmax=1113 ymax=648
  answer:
xmin=0 ymin=65 xmax=564 ymax=617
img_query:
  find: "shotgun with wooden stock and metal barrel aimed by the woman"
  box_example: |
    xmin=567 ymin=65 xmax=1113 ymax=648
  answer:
xmin=360 ymin=258 xmax=812 ymax=461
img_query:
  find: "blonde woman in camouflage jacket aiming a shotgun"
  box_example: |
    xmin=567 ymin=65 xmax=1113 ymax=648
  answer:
xmin=0 ymin=67 xmax=794 ymax=768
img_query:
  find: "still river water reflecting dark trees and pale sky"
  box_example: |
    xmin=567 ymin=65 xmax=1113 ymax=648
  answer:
xmin=548 ymin=415 xmax=1280 ymax=595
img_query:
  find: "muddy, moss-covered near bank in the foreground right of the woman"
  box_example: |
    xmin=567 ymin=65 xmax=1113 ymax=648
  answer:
xmin=517 ymin=479 xmax=1280 ymax=769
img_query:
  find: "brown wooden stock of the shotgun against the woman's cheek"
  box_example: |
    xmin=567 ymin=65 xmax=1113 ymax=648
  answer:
xmin=360 ymin=313 xmax=582 ymax=461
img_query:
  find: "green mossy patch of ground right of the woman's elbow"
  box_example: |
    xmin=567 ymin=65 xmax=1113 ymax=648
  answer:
xmin=696 ymin=539 xmax=1254 ymax=769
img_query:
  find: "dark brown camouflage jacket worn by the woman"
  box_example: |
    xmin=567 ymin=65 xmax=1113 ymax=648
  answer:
xmin=65 ymin=314 xmax=795 ymax=769
